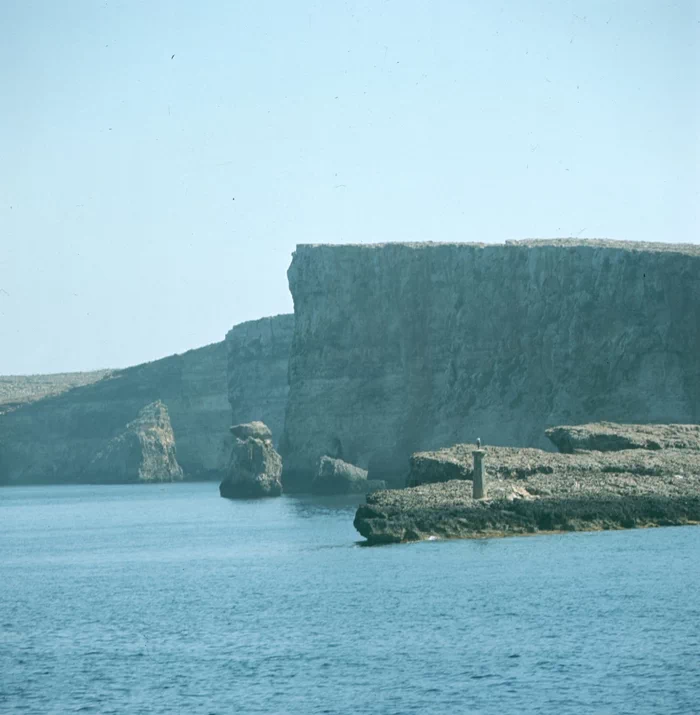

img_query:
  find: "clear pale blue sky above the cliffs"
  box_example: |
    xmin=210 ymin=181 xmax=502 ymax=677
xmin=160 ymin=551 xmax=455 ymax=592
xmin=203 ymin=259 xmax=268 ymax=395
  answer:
xmin=0 ymin=0 xmax=700 ymax=374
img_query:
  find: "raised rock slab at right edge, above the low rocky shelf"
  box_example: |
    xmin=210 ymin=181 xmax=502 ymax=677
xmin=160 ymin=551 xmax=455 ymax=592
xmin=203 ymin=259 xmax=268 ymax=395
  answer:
xmin=545 ymin=422 xmax=700 ymax=453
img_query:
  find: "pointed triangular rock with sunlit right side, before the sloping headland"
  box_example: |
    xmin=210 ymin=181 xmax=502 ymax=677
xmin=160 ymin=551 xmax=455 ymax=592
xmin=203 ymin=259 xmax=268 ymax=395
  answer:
xmin=81 ymin=401 xmax=183 ymax=484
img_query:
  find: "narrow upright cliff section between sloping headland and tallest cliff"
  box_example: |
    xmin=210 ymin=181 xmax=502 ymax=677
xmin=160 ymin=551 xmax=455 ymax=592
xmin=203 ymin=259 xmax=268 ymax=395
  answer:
xmin=226 ymin=315 xmax=294 ymax=445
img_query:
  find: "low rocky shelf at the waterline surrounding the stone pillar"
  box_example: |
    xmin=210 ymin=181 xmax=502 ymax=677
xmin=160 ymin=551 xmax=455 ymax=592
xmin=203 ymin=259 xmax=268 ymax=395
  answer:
xmin=354 ymin=445 xmax=700 ymax=544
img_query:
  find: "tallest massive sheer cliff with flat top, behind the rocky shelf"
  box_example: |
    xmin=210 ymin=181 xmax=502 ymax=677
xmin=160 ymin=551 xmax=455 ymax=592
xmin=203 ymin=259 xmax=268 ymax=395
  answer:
xmin=281 ymin=240 xmax=700 ymax=488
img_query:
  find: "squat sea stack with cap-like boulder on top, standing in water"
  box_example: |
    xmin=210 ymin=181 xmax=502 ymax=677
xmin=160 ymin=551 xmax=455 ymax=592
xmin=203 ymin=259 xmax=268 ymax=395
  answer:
xmin=219 ymin=422 xmax=282 ymax=499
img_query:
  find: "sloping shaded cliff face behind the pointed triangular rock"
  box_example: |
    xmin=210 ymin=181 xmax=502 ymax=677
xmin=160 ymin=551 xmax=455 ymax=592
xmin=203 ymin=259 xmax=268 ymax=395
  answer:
xmin=0 ymin=342 xmax=232 ymax=484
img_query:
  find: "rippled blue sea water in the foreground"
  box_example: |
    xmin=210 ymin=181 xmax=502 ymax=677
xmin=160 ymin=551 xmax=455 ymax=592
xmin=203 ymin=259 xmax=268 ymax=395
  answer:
xmin=0 ymin=483 xmax=700 ymax=715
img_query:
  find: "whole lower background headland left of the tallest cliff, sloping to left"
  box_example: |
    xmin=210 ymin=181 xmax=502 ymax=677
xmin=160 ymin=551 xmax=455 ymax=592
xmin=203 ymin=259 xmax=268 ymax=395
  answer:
xmin=0 ymin=316 xmax=293 ymax=484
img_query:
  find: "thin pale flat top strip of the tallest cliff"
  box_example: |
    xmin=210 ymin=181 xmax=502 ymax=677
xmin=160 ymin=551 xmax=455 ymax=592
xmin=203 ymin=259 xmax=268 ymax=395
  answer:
xmin=297 ymin=238 xmax=700 ymax=256
